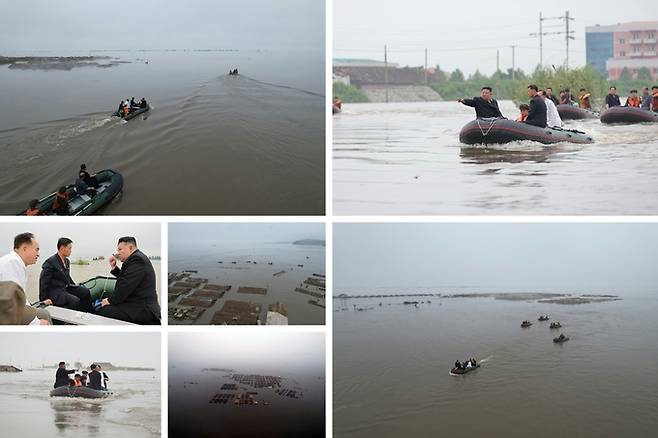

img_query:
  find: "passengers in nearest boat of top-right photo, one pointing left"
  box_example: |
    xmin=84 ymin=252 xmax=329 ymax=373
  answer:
xmin=458 ymin=84 xmax=562 ymax=128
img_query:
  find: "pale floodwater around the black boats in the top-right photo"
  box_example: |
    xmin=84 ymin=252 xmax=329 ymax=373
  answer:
xmin=333 ymin=101 xmax=658 ymax=215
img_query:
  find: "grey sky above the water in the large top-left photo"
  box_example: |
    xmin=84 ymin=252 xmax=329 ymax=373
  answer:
xmin=0 ymin=0 xmax=325 ymax=54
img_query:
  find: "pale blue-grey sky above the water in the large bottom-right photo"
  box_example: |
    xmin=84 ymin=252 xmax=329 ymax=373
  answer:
xmin=333 ymin=223 xmax=658 ymax=293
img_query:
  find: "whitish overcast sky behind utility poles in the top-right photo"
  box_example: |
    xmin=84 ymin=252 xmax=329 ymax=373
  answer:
xmin=333 ymin=0 xmax=658 ymax=74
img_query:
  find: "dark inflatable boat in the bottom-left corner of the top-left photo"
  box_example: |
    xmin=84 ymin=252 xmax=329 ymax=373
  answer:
xmin=18 ymin=169 xmax=123 ymax=216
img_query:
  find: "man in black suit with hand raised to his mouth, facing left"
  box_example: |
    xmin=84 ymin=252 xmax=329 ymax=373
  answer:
xmin=98 ymin=237 xmax=160 ymax=324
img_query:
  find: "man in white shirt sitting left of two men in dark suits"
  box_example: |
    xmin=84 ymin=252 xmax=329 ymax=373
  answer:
xmin=0 ymin=233 xmax=52 ymax=325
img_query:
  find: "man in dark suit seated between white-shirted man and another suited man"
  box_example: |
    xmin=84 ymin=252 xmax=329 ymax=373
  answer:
xmin=39 ymin=237 xmax=91 ymax=312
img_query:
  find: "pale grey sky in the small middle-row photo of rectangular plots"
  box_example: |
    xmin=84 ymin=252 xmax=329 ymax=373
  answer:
xmin=169 ymin=222 xmax=325 ymax=246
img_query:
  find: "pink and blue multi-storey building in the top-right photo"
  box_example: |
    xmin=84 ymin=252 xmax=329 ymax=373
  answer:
xmin=585 ymin=21 xmax=658 ymax=80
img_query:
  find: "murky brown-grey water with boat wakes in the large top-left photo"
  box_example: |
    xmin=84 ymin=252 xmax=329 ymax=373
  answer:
xmin=0 ymin=50 xmax=325 ymax=215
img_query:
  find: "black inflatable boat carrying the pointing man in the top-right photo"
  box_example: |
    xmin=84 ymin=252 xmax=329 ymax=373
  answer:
xmin=459 ymin=118 xmax=594 ymax=145
